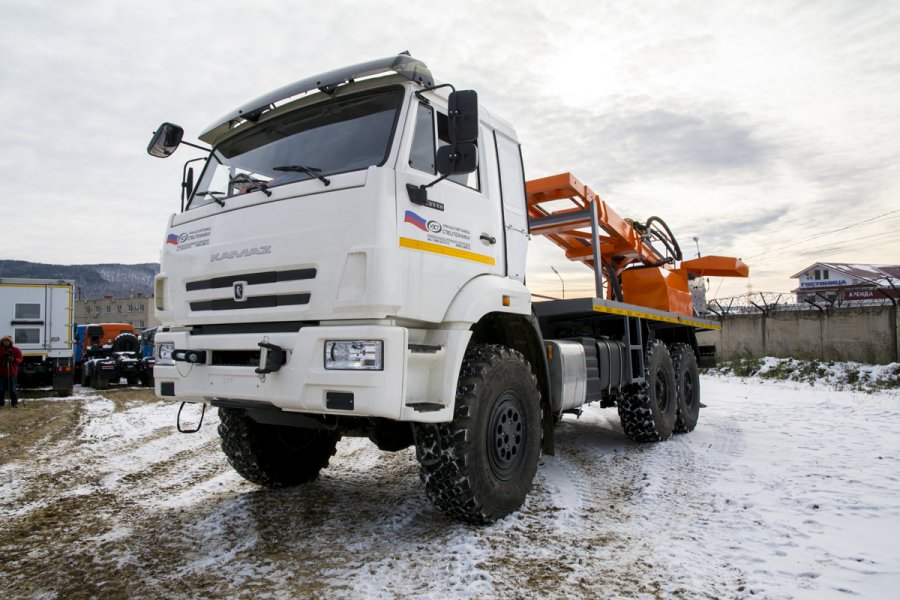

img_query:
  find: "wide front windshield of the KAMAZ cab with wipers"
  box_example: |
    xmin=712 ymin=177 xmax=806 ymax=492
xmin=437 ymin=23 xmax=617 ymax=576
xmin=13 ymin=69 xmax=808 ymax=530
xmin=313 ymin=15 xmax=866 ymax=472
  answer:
xmin=188 ymin=87 xmax=403 ymax=209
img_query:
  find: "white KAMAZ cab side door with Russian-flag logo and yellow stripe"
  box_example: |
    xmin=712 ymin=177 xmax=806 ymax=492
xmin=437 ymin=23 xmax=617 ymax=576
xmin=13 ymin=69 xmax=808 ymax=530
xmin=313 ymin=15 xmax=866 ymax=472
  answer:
xmin=397 ymin=94 xmax=506 ymax=319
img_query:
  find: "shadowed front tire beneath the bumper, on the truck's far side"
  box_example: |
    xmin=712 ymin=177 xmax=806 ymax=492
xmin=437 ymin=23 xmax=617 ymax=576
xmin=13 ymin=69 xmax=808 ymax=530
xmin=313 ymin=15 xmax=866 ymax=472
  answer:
xmin=219 ymin=408 xmax=341 ymax=488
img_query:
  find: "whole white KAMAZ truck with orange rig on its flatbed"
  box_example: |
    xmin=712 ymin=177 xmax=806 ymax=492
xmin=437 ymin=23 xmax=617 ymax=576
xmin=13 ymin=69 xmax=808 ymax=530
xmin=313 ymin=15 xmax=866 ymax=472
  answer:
xmin=148 ymin=54 xmax=748 ymax=523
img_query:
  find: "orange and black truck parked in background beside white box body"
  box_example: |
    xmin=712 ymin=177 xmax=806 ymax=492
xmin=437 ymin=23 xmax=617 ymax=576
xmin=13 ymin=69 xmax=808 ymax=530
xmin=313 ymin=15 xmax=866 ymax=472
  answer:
xmin=75 ymin=323 xmax=154 ymax=390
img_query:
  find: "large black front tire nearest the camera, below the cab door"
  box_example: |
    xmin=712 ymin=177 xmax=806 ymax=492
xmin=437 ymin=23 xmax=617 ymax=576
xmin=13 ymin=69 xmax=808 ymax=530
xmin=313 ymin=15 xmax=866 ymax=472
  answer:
xmin=415 ymin=345 xmax=541 ymax=524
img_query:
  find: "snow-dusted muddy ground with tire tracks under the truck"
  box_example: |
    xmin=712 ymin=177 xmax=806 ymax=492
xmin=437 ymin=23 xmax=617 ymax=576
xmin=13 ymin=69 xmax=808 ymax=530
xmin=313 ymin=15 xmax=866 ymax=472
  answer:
xmin=0 ymin=377 xmax=900 ymax=600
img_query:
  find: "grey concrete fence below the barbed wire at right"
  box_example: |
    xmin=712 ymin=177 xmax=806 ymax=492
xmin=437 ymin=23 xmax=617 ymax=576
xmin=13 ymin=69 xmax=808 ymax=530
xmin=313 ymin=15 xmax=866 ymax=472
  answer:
xmin=697 ymin=304 xmax=900 ymax=364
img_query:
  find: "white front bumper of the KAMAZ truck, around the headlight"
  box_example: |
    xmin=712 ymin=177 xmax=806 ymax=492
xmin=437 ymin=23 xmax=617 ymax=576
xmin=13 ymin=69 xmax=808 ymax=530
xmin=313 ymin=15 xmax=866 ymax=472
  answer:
xmin=153 ymin=325 xmax=471 ymax=423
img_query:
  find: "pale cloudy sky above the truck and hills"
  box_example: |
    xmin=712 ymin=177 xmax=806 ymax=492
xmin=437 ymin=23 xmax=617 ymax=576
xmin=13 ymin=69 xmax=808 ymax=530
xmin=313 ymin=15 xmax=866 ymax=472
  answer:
xmin=0 ymin=0 xmax=900 ymax=298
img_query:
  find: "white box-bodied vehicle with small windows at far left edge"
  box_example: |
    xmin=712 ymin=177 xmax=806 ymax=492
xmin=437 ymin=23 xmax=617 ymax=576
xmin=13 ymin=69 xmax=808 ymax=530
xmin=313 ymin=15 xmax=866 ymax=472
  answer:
xmin=0 ymin=277 xmax=75 ymax=395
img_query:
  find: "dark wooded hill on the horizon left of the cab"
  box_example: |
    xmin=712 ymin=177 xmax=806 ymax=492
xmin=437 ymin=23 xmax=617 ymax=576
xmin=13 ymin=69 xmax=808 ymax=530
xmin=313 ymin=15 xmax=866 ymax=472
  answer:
xmin=0 ymin=260 xmax=159 ymax=299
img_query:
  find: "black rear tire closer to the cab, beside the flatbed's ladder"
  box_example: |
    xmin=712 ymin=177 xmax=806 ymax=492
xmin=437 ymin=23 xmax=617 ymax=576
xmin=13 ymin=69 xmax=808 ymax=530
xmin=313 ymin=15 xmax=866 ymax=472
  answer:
xmin=617 ymin=340 xmax=678 ymax=442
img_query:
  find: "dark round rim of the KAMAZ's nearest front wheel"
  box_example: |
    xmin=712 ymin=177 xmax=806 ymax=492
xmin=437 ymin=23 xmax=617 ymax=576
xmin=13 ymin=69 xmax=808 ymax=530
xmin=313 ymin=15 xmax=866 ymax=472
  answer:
xmin=487 ymin=390 xmax=527 ymax=481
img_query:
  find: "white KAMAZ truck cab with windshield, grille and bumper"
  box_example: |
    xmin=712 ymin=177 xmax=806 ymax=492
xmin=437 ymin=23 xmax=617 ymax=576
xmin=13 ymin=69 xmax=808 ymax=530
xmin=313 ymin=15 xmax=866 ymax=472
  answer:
xmin=155 ymin=56 xmax=531 ymax=422
